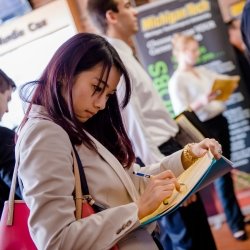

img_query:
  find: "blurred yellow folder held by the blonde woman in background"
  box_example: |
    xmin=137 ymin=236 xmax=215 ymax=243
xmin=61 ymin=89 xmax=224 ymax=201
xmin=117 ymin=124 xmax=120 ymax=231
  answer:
xmin=212 ymin=76 xmax=240 ymax=101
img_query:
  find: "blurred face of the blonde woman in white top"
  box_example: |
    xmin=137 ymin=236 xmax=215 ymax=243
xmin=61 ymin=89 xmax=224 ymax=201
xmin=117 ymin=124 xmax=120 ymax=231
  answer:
xmin=177 ymin=41 xmax=200 ymax=66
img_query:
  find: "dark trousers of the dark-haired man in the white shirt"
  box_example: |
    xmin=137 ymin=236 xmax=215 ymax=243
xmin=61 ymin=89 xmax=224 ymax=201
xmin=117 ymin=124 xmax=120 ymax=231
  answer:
xmin=158 ymin=138 xmax=216 ymax=250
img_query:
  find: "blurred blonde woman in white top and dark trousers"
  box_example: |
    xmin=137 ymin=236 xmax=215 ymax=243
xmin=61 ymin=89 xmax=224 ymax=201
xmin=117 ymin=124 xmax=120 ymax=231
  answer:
xmin=169 ymin=34 xmax=247 ymax=240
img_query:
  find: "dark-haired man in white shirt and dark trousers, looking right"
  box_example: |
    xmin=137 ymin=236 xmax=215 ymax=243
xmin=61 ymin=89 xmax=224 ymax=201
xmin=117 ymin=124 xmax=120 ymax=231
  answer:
xmin=88 ymin=0 xmax=216 ymax=250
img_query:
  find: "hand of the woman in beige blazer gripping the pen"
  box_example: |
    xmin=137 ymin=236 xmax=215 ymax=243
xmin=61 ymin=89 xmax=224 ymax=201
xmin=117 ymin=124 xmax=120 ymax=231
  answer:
xmin=136 ymin=170 xmax=180 ymax=219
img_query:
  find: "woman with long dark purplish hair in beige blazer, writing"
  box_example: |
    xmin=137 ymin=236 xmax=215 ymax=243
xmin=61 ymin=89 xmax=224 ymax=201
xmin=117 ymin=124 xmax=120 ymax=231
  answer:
xmin=16 ymin=34 xmax=220 ymax=250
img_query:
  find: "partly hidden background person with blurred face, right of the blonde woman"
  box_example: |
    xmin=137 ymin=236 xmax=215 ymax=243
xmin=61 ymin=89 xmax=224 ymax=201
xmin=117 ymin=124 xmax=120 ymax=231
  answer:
xmin=227 ymin=18 xmax=250 ymax=94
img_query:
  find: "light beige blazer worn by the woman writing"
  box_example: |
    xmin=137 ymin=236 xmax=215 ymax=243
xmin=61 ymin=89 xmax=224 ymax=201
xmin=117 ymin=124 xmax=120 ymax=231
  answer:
xmin=16 ymin=105 xmax=184 ymax=250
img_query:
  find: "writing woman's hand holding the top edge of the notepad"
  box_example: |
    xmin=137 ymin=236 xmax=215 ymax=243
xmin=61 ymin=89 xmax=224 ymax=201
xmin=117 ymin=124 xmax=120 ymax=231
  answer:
xmin=190 ymin=138 xmax=222 ymax=159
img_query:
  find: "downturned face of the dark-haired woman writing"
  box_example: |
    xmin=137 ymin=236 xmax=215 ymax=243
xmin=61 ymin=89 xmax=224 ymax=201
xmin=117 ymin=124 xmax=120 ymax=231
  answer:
xmin=65 ymin=64 xmax=121 ymax=122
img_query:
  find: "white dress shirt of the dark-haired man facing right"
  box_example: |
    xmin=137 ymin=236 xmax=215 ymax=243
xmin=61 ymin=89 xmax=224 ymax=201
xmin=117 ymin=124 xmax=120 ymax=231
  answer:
xmin=108 ymin=38 xmax=178 ymax=164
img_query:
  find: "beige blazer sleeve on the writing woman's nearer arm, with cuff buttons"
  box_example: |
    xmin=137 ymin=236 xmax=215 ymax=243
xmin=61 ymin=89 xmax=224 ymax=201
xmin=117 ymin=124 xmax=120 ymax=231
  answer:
xmin=16 ymin=120 xmax=140 ymax=250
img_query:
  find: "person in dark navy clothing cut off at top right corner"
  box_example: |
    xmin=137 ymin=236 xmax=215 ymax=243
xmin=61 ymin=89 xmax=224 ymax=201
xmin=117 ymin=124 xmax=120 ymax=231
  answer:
xmin=241 ymin=0 xmax=250 ymax=55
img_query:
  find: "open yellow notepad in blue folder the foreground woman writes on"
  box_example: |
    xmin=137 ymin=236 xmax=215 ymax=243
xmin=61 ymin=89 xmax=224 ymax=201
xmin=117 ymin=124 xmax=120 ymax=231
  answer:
xmin=140 ymin=152 xmax=233 ymax=225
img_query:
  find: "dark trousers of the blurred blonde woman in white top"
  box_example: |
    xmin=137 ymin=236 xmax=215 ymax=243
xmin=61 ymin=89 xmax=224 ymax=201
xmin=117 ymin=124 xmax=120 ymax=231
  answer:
xmin=203 ymin=115 xmax=244 ymax=233
